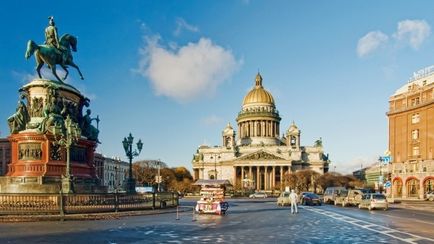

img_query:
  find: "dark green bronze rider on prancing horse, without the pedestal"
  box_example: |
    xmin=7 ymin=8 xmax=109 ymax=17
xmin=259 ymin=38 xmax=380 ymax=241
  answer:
xmin=25 ymin=16 xmax=84 ymax=82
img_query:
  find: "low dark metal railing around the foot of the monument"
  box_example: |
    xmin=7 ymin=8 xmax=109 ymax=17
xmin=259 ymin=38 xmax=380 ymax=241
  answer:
xmin=0 ymin=192 xmax=179 ymax=215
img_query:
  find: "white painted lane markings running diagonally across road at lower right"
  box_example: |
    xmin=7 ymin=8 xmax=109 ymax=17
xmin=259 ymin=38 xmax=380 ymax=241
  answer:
xmin=303 ymin=207 xmax=434 ymax=243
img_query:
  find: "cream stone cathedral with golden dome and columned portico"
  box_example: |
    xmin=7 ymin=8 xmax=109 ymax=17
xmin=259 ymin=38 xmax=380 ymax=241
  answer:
xmin=192 ymin=73 xmax=329 ymax=191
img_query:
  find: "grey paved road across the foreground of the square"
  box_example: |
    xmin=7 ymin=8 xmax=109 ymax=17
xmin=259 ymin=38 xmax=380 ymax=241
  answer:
xmin=0 ymin=199 xmax=434 ymax=244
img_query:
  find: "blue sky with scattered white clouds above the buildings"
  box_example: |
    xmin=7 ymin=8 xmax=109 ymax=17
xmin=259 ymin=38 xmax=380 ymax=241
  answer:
xmin=0 ymin=0 xmax=434 ymax=173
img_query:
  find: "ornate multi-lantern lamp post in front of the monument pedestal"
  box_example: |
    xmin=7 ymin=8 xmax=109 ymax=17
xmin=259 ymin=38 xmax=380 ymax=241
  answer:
xmin=53 ymin=115 xmax=81 ymax=193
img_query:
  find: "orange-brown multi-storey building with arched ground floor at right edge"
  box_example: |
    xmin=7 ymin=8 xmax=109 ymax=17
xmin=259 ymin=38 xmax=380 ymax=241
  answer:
xmin=387 ymin=66 xmax=434 ymax=199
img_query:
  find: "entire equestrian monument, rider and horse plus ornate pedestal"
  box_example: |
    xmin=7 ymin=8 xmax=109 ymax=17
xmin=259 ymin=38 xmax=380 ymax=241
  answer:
xmin=1 ymin=17 xmax=100 ymax=192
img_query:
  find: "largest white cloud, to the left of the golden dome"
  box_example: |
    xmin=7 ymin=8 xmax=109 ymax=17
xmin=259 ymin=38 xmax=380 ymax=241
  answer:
xmin=133 ymin=36 xmax=241 ymax=102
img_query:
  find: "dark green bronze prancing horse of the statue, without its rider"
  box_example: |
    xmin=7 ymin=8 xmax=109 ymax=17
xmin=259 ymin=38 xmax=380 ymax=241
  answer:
xmin=25 ymin=34 xmax=84 ymax=82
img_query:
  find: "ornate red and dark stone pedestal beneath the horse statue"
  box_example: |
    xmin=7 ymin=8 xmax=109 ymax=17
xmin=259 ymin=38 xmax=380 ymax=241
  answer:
xmin=4 ymin=79 xmax=102 ymax=193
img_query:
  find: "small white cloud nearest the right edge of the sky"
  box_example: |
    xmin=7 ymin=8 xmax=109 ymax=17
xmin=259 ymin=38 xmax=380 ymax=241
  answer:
xmin=393 ymin=20 xmax=431 ymax=49
